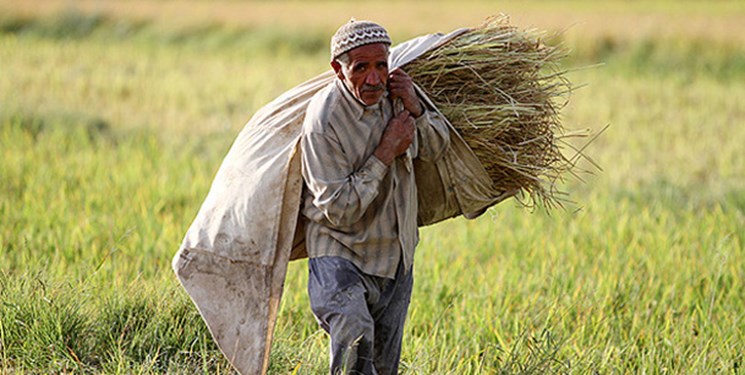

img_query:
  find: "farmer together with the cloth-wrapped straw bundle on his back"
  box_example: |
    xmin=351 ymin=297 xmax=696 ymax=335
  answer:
xmin=173 ymin=16 xmax=576 ymax=374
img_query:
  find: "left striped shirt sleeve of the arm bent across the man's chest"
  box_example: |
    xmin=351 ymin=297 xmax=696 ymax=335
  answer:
xmin=301 ymin=132 xmax=388 ymax=227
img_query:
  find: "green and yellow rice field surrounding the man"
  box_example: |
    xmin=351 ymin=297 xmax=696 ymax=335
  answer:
xmin=0 ymin=0 xmax=745 ymax=374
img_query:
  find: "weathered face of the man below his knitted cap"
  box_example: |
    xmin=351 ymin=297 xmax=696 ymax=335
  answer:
xmin=331 ymin=43 xmax=388 ymax=105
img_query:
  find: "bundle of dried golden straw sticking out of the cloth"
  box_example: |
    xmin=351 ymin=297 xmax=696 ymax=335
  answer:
xmin=405 ymin=16 xmax=573 ymax=208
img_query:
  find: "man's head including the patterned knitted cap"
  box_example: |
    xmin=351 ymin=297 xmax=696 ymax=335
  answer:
xmin=331 ymin=20 xmax=391 ymax=105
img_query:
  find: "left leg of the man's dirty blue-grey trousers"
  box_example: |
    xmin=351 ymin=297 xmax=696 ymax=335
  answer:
xmin=308 ymin=257 xmax=377 ymax=374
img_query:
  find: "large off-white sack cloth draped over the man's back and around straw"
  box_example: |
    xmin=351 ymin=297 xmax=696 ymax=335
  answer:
xmin=173 ymin=29 xmax=515 ymax=374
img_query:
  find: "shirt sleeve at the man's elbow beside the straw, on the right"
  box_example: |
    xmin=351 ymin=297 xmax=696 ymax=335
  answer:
xmin=415 ymin=104 xmax=450 ymax=162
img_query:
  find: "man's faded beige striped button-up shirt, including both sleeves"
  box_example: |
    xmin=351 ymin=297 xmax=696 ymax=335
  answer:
xmin=301 ymin=79 xmax=449 ymax=278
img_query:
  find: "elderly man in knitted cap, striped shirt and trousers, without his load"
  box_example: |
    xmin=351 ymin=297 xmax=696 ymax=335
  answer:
xmin=301 ymin=20 xmax=449 ymax=374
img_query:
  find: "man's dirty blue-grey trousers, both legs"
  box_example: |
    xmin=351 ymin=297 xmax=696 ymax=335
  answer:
xmin=308 ymin=256 xmax=413 ymax=375
